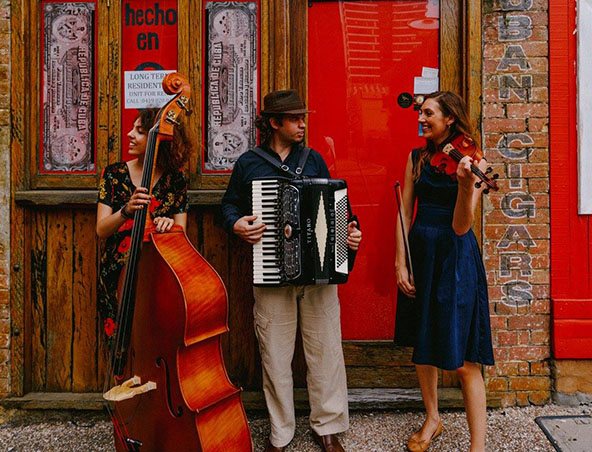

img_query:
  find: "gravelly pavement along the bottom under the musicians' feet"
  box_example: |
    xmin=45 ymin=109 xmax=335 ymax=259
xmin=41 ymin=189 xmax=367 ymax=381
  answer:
xmin=0 ymin=405 xmax=592 ymax=452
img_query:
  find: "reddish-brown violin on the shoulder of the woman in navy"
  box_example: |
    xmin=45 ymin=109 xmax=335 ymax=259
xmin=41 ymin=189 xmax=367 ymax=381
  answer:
xmin=430 ymin=133 xmax=499 ymax=194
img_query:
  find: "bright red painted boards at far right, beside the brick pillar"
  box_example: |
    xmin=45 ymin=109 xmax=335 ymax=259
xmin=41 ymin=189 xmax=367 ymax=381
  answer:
xmin=549 ymin=0 xmax=592 ymax=358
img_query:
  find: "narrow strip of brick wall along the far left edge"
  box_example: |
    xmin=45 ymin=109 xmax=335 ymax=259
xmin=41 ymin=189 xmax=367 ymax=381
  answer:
xmin=0 ymin=0 xmax=10 ymax=398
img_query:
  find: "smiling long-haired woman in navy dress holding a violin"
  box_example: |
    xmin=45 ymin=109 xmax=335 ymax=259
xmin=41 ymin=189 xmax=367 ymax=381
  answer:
xmin=395 ymin=91 xmax=493 ymax=452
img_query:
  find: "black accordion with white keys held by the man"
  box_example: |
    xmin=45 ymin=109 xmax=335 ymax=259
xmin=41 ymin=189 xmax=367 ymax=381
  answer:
xmin=252 ymin=178 xmax=348 ymax=286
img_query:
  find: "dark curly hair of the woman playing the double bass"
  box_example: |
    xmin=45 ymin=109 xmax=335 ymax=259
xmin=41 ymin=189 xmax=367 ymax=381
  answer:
xmin=134 ymin=108 xmax=193 ymax=171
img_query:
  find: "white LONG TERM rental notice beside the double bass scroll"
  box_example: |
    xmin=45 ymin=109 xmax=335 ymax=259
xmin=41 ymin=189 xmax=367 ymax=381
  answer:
xmin=124 ymin=70 xmax=175 ymax=109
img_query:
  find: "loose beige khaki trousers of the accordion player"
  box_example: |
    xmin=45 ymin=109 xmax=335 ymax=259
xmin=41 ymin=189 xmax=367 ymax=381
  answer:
xmin=253 ymin=285 xmax=349 ymax=447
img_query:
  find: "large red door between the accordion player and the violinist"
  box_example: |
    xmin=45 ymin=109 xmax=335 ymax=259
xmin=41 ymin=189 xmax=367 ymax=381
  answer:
xmin=308 ymin=0 xmax=439 ymax=340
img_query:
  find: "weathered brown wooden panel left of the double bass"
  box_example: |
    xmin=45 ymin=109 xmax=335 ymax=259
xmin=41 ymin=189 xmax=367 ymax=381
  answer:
xmin=25 ymin=208 xmax=104 ymax=392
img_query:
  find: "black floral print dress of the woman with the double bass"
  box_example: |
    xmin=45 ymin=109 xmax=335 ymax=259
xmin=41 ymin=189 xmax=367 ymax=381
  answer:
xmin=97 ymin=162 xmax=187 ymax=341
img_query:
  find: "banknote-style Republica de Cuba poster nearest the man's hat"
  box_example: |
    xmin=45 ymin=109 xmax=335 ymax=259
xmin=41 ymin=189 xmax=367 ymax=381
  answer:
xmin=203 ymin=2 xmax=259 ymax=173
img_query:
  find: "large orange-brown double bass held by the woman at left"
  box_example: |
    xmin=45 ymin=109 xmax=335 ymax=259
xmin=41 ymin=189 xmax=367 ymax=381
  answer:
xmin=103 ymin=73 xmax=253 ymax=452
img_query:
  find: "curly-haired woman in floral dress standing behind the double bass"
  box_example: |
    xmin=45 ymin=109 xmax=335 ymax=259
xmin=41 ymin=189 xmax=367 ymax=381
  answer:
xmin=97 ymin=109 xmax=191 ymax=338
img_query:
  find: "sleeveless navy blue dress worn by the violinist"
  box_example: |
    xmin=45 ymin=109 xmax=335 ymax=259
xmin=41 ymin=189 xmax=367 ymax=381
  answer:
xmin=395 ymin=149 xmax=493 ymax=370
